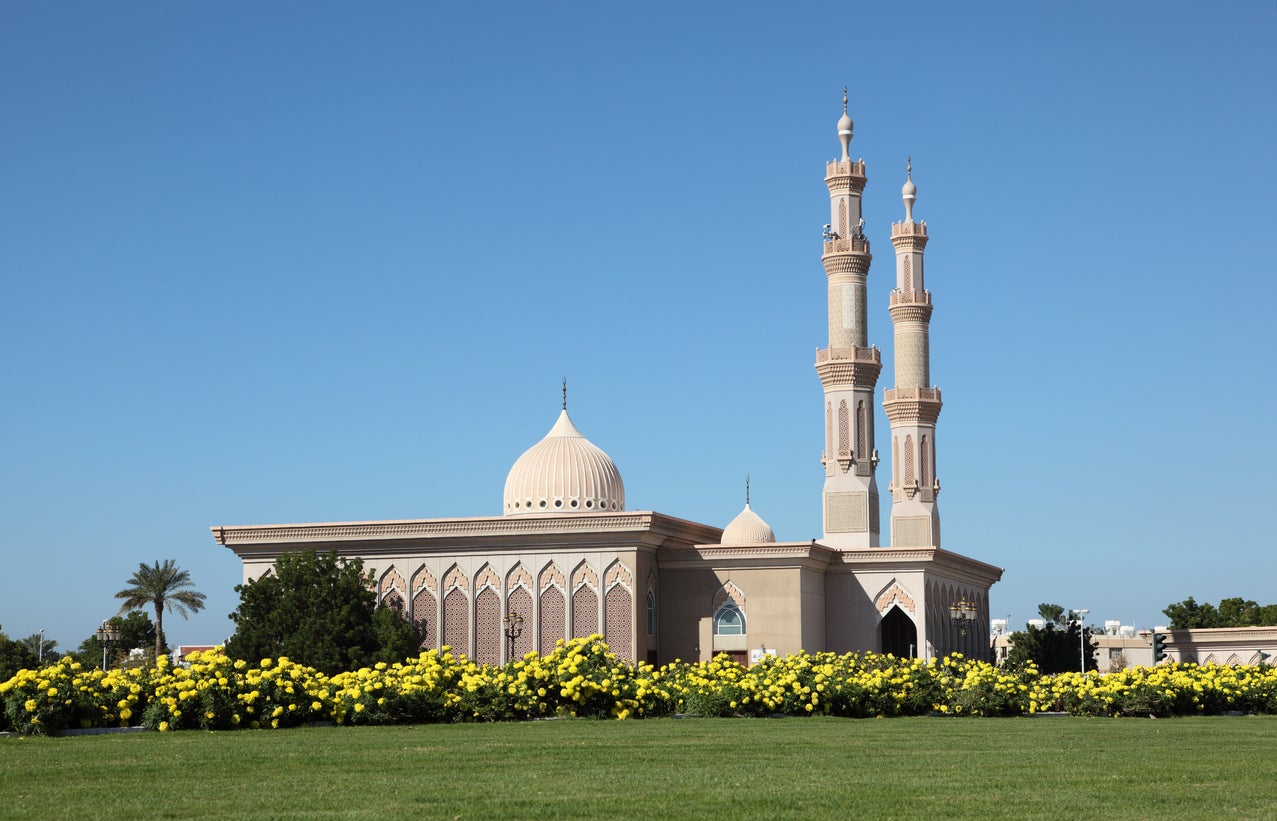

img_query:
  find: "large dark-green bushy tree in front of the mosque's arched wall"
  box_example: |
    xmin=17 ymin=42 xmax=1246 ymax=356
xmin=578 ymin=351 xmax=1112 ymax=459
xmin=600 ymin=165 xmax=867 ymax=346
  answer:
xmin=226 ymin=550 xmax=416 ymax=675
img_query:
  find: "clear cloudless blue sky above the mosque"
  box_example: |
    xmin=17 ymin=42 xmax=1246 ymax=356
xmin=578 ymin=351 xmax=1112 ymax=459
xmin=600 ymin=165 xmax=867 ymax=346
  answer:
xmin=0 ymin=0 xmax=1277 ymax=649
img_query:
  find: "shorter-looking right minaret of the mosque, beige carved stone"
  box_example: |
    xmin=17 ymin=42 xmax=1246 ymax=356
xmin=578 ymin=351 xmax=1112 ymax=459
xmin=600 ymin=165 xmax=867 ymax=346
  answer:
xmin=882 ymin=158 xmax=941 ymax=548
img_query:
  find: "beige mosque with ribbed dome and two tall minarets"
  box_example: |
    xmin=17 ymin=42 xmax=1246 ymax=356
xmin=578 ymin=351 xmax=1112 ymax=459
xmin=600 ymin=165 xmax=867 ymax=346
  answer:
xmin=211 ymin=99 xmax=1002 ymax=664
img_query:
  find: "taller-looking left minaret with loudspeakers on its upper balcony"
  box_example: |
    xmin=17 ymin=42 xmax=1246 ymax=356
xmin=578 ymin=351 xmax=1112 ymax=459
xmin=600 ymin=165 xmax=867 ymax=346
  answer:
xmin=816 ymin=88 xmax=882 ymax=548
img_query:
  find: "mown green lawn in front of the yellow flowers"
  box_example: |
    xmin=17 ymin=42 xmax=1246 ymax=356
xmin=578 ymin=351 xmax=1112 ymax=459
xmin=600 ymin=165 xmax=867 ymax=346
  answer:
xmin=0 ymin=716 xmax=1277 ymax=818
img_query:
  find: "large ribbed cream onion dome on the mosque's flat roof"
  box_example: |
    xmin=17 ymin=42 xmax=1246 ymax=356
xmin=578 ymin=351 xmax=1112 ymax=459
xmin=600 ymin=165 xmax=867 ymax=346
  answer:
xmin=504 ymin=409 xmax=626 ymax=516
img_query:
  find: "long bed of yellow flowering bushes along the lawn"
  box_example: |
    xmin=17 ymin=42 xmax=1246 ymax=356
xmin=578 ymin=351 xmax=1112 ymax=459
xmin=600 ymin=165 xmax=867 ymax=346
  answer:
xmin=0 ymin=636 xmax=1277 ymax=734
